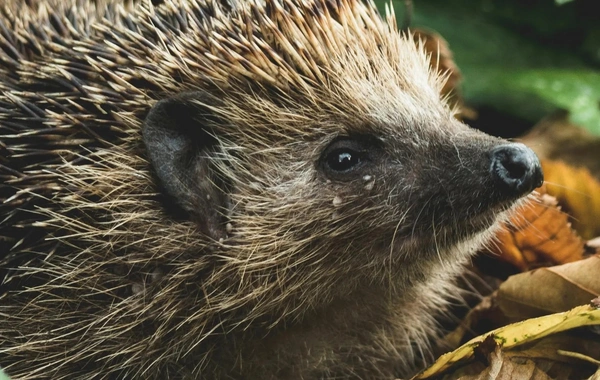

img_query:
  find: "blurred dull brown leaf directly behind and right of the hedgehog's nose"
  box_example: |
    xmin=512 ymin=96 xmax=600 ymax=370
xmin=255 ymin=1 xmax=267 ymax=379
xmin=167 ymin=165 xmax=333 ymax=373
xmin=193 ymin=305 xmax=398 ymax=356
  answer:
xmin=519 ymin=111 xmax=600 ymax=179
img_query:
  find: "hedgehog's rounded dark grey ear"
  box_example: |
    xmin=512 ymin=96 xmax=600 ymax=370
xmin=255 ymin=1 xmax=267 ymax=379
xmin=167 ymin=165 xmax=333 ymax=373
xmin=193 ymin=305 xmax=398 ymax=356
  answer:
xmin=142 ymin=92 xmax=227 ymax=240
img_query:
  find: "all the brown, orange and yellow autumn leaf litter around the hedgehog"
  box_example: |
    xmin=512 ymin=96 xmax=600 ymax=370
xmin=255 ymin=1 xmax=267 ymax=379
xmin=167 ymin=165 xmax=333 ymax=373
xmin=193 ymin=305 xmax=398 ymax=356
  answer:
xmin=413 ymin=2 xmax=600 ymax=380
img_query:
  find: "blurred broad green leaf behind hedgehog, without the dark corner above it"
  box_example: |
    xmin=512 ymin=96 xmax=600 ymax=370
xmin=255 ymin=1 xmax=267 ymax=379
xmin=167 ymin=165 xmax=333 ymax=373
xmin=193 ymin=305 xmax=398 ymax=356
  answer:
xmin=376 ymin=0 xmax=600 ymax=135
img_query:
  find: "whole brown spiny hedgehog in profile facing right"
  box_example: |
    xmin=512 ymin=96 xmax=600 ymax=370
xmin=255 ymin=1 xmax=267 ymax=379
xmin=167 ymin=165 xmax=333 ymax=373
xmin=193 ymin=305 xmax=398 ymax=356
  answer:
xmin=0 ymin=0 xmax=542 ymax=380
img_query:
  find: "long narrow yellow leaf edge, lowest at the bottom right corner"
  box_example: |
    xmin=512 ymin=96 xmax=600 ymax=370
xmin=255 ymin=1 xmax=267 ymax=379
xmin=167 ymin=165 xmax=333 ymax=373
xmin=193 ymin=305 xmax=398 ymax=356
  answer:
xmin=412 ymin=305 xmax=600 ymax=380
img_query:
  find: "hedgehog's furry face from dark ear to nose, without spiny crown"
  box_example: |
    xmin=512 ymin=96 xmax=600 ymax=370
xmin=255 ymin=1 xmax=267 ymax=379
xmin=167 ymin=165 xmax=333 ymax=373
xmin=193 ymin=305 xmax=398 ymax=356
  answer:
xmin=144 ymin=87 xmax=541 ymax=294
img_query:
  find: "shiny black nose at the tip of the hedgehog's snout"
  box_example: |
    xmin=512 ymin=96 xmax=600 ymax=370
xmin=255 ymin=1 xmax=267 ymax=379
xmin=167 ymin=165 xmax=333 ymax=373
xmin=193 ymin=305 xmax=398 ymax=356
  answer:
xmin=490 ymin=143 xmax=544 ymax=197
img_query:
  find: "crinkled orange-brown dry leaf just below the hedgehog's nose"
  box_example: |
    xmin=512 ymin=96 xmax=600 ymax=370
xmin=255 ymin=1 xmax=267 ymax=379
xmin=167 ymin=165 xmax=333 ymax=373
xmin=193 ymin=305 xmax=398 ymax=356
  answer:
xmin=482 ymin=194 xmax=584 ymax=271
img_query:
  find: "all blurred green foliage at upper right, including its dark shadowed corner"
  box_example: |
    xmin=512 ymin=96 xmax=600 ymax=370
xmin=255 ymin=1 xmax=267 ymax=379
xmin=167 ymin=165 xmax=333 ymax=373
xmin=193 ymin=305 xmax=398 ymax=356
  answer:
xmin=376 ymin=0 xmax=600 ymax=135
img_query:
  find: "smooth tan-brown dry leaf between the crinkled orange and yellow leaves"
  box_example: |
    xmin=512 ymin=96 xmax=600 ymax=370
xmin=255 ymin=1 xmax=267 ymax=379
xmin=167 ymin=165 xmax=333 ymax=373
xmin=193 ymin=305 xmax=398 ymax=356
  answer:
xmin=496 ymin=255 xmax=600 ymax=321
